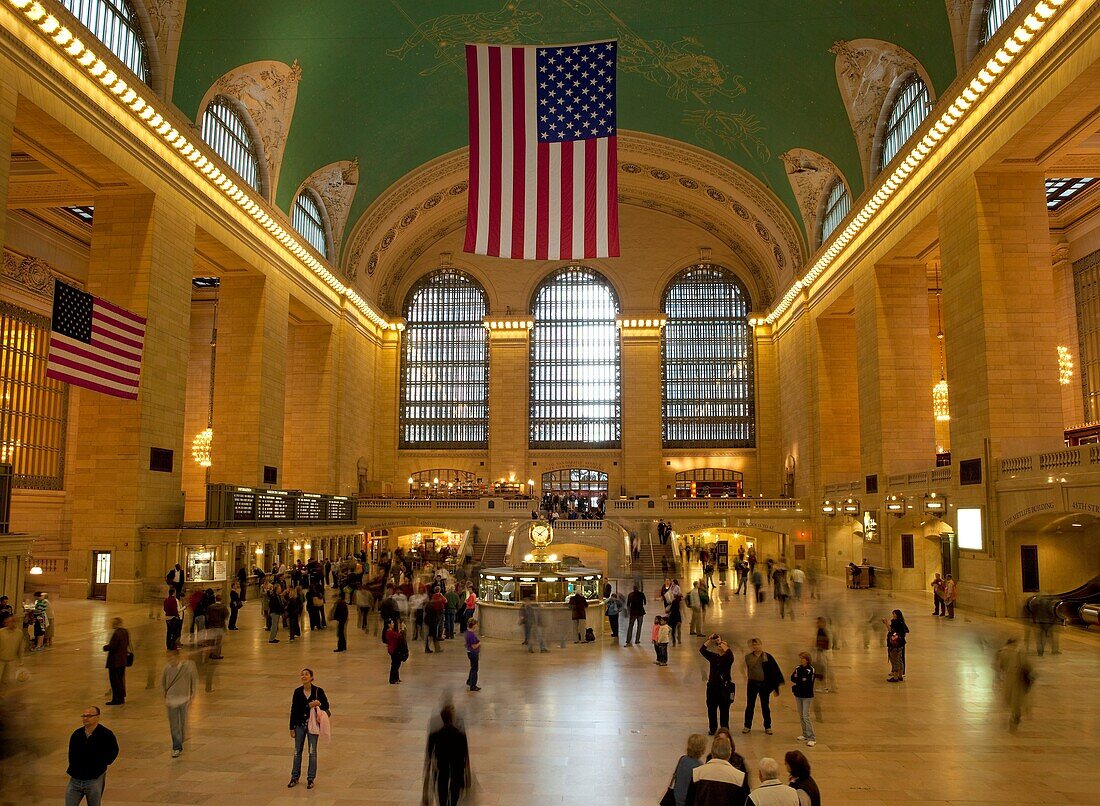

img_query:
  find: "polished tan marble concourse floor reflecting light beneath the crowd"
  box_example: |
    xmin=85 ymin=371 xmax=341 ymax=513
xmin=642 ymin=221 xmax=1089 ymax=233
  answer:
xmin=0 ymin=571 xmax=1100 ymax=806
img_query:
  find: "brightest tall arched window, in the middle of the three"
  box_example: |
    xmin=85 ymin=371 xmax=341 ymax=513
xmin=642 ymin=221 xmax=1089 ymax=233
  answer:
xmin=530 ymin=266 xmax=622 ymax=448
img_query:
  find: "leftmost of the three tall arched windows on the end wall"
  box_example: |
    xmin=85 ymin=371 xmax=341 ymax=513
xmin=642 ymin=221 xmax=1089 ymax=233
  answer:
xmin=400 ymin=268 xmax=488 ymax=448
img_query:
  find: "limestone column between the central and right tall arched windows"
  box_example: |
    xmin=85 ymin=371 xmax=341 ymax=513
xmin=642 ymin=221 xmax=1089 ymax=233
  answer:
xmin=618 ymin=314 xmax=662 ymax=498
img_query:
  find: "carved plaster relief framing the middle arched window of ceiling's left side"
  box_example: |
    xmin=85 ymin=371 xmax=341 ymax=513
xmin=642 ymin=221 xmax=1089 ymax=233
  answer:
xmin=199 ymin=59 xmax=301 ymax=199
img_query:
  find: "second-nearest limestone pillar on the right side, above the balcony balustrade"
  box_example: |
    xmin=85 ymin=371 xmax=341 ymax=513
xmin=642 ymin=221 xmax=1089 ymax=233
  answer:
xmin=855 ymin=263 xmax=936 ymax=477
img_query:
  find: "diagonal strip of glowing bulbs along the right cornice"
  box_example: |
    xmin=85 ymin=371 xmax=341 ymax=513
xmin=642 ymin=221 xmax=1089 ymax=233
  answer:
xmin=758 ymin=0 xmax=1077 ymax=324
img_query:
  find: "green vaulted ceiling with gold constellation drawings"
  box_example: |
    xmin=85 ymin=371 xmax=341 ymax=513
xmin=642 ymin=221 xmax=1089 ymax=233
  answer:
xmin=173 ymin=0 xmax=955 ymax=246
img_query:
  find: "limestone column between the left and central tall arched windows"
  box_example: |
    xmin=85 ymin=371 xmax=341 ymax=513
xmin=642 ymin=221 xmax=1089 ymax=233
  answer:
xmin=485 ymin=317 xmax=530 ymax=483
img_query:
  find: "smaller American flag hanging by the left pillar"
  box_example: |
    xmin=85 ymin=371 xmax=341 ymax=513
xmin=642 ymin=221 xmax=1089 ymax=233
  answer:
xmin=46 ymin=280 xmax=145 ymax=400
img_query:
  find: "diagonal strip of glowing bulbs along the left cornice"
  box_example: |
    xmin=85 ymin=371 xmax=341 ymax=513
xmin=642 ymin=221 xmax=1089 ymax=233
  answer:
xmin=8 ymin=0 xmax=398 ymax=330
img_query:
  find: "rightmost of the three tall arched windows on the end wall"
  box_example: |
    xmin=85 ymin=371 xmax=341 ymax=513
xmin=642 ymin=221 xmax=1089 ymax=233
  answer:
xmin=661 ymin=265 xmax=756 ymax=448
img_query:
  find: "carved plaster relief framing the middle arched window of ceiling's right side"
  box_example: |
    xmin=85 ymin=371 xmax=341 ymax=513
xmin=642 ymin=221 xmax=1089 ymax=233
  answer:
xmin=829 ymin=40 xmax=933 ymax=185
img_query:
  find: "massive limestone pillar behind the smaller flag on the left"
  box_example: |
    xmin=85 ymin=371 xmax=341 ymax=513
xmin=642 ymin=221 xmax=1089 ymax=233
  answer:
xmin=62 ymin=192 xmax=195 ymax=601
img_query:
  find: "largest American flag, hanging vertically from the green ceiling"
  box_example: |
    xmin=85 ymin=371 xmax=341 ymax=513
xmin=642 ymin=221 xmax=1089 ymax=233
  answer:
xmin=465 ymin=42 xmax=619 ymax=261
